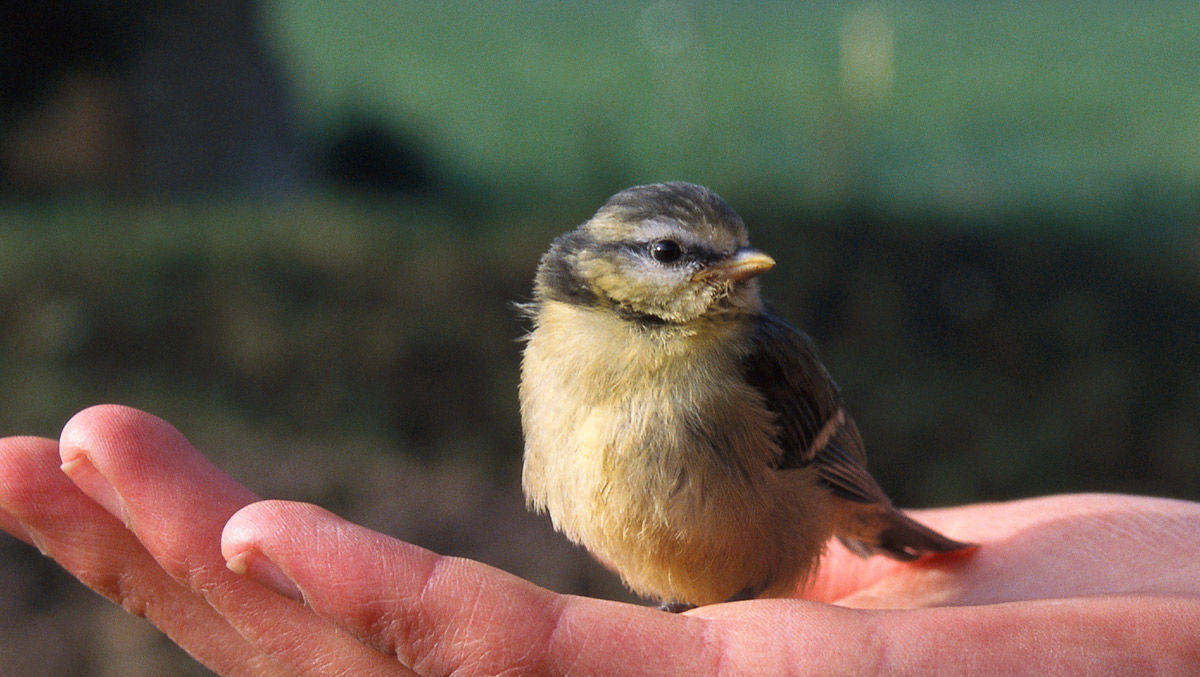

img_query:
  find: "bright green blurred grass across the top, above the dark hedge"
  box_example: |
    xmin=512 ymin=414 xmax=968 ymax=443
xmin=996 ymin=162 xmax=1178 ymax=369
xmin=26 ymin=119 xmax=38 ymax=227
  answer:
xmin=266 ymin=0 xmax=1200 ymax=225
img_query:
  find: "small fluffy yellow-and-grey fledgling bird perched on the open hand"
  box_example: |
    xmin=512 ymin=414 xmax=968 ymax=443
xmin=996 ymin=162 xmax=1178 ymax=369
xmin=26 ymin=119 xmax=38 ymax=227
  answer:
xmin=520 ymin=182 xmax=973 ymax=611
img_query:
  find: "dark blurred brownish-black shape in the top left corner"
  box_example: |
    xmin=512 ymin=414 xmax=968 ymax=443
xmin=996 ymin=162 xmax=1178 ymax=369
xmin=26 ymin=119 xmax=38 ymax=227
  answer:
xmin=0 ymin=0 xmax=305 ymax=199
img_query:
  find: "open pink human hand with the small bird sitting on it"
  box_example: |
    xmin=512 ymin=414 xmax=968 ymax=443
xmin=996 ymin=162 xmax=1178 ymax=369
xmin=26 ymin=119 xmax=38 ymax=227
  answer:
xmin=0 ymin=406 xmax=1200 ymax=675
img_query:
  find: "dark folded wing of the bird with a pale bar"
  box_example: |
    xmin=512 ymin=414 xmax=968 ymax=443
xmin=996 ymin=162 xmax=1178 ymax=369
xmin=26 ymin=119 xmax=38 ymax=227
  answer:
xmin=742 ymin=313 xmax=889 ymax=505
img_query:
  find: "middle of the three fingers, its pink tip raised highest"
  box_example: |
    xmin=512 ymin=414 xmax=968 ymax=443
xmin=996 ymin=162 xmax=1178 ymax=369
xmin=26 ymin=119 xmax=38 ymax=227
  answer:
xmin=60 ymin=406 xmax=396 ymax=675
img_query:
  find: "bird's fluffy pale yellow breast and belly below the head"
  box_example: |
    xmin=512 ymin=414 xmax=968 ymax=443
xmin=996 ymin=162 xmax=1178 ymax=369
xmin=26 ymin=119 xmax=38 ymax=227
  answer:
xmin=521 ymin=304 xmax=829 ymax=604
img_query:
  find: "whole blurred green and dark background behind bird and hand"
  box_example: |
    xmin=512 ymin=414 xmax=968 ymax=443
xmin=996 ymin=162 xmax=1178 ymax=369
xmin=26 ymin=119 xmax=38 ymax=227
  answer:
xmin=0 ymin=0 xmax=1200 ymax=675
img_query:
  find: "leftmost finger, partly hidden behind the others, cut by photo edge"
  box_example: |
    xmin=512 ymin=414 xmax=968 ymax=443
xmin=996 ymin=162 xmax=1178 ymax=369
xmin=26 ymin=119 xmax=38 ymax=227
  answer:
xmin=0 ymin=437 xmax=274 ymax=673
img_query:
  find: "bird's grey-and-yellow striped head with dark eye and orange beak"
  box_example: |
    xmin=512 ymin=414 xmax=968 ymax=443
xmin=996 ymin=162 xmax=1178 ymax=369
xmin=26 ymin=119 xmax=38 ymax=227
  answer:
xmin=535 ymin=182 xmax=775 ymax=324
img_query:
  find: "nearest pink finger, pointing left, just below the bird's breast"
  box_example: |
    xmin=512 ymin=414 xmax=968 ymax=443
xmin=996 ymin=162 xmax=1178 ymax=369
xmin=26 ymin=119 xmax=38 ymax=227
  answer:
xmin=222 ymin=501 xmax=721 ymax=675
